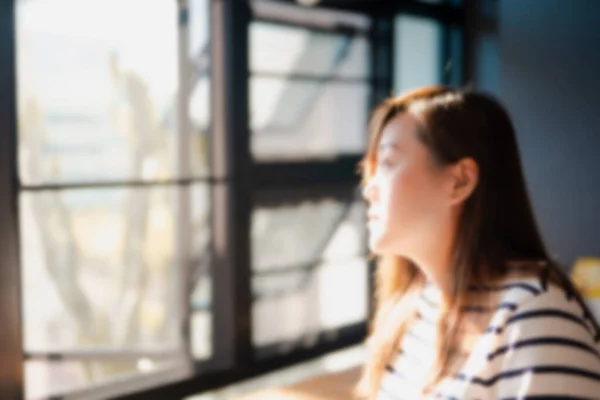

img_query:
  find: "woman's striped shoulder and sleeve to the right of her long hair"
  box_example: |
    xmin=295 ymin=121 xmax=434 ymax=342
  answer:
xmin=466 ymin=271 xmax=600 ymax=398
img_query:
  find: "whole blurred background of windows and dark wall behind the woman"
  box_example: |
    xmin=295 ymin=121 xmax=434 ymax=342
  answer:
xmin=0 ymin=0 xmax=600 ymax=400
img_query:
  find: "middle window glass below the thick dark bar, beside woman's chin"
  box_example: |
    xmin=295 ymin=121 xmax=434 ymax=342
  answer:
xmin=252 ymin=199 xmax=368 ymax=346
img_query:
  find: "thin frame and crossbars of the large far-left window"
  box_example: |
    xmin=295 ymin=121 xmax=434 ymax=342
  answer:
xmin=11 ymin=0 xmax=202 ymax=399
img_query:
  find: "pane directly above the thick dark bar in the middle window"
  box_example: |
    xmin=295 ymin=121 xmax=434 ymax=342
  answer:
xmin=250 ymin=77 xmax=371 ymax=161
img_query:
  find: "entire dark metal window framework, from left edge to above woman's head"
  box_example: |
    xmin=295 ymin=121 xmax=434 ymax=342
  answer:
xmin=0 ymin=0 xmax=467 ymax=399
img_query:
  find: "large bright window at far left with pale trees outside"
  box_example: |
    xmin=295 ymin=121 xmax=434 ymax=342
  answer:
xmin=16 ymin=0 xmax=212 ymax=398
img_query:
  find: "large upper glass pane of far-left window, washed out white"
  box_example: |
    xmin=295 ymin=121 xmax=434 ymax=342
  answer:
xmin=16 ymin=0 xmax=208 ymax=184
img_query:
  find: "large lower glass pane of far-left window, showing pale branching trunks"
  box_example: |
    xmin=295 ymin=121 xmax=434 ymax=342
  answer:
xmin=20 ymin=186 xmax=209 ymax=352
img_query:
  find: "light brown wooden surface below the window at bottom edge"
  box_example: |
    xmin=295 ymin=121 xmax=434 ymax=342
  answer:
xmin=235 ymin=368 xmax=360 ymax=400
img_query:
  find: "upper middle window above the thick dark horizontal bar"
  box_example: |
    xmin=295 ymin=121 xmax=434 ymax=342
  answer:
xmin=249 ymin=4 xmax=371 ymax=161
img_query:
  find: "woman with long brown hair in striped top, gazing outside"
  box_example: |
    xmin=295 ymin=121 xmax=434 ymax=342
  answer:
xmin=360 ymin=87 xmax=600 ymax=399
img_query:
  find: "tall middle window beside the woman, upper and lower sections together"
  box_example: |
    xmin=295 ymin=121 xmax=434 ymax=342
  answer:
xmin=249 ymin=2 xmax=370 ymax=359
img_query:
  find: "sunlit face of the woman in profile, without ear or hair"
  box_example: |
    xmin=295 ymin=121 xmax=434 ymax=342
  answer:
xmin=363 ymin=112 xmax=451 ymax=258
